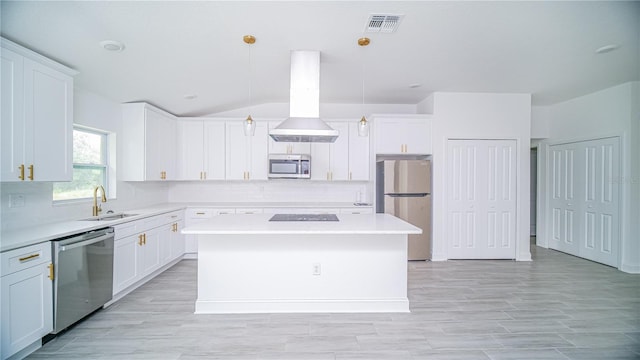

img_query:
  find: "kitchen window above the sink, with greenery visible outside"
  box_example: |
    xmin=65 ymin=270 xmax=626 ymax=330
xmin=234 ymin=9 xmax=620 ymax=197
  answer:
xmin=53 ymin=125 xmax=115 ymax=202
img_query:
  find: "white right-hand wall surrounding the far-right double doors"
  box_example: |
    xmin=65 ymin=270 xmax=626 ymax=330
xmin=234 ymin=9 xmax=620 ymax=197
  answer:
xmin=538 ymin=81 xmax=640 ymax=273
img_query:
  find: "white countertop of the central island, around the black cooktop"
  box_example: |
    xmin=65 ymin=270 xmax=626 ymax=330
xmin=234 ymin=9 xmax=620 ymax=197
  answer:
xmin=182 ymin=214 xmax=422 ymax=235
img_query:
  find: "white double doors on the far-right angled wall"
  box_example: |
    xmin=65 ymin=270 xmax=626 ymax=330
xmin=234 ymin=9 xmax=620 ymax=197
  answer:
xmin=548 ymin=137 xmax=620 ymax=267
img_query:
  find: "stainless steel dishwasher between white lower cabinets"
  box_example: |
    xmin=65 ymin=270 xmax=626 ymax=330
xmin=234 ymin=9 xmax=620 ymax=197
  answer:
xmin=51 ymin=228 xmax=114 ymax=334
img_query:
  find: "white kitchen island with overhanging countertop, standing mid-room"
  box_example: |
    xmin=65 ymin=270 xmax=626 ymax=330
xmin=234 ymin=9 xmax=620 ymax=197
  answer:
xmin=182 ymin=214 xmax=422 ymax=314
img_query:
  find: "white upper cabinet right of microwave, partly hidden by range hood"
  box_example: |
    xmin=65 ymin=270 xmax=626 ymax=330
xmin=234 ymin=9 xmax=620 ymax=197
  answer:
xmin=311 ymin=122 xmax=349 ymax=181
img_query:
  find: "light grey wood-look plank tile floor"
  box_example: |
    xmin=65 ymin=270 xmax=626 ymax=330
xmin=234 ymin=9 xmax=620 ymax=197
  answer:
xmin=29 ymin=247 xmax=640 ymax=360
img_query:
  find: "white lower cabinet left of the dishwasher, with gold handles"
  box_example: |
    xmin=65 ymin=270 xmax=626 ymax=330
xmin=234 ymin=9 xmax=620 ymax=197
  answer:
xmin=0 ymin=241 xmax=53 ymax=359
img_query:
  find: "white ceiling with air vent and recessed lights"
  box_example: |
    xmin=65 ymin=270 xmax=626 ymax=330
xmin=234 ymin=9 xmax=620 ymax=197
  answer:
xmin=1 ymin=0 xmax=640 ymax=116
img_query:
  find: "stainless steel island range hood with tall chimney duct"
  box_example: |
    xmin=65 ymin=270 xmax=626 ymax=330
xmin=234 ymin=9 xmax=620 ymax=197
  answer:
xmin=269 ymin=50 xmax=338 ymax=143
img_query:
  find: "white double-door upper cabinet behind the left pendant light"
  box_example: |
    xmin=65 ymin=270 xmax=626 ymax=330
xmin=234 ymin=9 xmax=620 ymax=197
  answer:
xmin=225 ymin=120 xmax=268 ymax=180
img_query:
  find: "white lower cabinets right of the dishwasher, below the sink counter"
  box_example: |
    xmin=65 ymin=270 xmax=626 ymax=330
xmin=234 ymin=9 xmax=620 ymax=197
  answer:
xmin=113 ymin=211 xmax=184 ymax=296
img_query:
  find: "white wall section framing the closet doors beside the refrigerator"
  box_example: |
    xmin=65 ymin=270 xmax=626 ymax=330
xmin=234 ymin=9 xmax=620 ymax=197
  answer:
xmin=432 ymin=93 xmax=531 ymax=261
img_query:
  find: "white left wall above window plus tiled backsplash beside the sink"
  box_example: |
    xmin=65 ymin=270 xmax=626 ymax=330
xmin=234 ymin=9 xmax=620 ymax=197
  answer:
xmin=0 ymin=87 xmax=167 ymax=231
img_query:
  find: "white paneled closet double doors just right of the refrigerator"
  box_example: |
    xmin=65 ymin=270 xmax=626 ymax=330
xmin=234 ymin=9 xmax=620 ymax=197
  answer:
xmin=447 ymin=140 xmax=517 ymax=259
